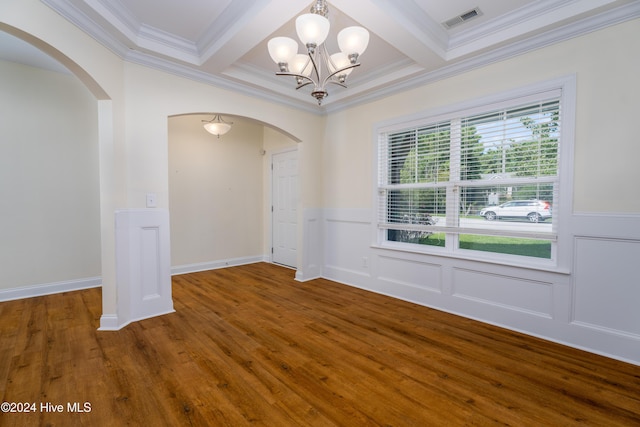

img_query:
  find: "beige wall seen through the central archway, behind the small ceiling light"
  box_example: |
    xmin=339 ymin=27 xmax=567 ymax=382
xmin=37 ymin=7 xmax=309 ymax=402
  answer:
xmin=169 ymin=115 xmax=266 ymax=266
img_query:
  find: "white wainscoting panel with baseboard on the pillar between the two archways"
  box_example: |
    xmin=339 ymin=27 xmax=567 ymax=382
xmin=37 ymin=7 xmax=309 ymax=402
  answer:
xmin=100 ymin=209 xmax=174 ymax=330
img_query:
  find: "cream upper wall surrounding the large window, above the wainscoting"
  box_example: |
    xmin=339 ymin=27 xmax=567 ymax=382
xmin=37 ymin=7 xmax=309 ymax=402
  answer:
xmin=323 ymin=20 xmax=640 ymax=213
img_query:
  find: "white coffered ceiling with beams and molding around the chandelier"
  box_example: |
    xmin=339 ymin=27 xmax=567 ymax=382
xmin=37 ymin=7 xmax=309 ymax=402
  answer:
xmin=5 ymin=0 xmax=640 ymax=113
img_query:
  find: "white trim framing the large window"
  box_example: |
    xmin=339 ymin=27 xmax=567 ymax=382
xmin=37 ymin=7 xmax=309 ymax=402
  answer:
xmin=371 ymin=75 xmax=576 ymax=274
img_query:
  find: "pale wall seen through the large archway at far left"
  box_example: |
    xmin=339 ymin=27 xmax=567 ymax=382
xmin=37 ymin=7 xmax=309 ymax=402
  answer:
xmin=0 ymin=61 xmax=101 ymax=289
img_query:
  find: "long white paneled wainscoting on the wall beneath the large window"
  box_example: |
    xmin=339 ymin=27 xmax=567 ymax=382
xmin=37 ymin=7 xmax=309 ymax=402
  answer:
xmin=322 ymin=209 xmax=640 ymax=365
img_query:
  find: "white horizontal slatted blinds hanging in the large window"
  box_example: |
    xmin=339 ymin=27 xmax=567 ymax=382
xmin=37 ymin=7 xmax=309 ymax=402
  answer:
xmin=378 ymin=93 xmax=561 ymax=239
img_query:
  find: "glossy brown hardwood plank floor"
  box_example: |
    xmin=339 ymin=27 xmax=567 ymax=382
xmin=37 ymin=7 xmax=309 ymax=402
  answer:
xmin=0 ymin=263 xmax=640 ymax=427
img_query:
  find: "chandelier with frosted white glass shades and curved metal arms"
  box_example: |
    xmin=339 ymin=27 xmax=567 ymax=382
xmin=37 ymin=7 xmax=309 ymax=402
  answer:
xmin=268 ymin=0 xmax=369 ymax=105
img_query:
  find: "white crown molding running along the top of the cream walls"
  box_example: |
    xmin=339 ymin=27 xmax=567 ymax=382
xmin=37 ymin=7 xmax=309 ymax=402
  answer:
xmin=41 ymin=0 xmax=640 ymax=115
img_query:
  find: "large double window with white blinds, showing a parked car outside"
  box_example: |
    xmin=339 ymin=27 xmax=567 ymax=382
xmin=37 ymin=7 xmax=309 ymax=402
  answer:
xmin=376 ymin=80 xmax=574 ymax=266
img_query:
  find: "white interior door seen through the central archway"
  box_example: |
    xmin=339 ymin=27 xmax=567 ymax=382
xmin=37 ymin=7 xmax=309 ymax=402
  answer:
xmin=271 ymin=150 xmax=299 ymax=268
